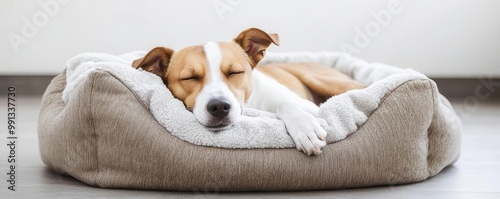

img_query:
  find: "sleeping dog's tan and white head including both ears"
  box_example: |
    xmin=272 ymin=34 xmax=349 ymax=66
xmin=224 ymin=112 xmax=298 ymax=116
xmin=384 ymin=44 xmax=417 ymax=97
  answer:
xmin=132 ymin=28 xmax=279 ymax=130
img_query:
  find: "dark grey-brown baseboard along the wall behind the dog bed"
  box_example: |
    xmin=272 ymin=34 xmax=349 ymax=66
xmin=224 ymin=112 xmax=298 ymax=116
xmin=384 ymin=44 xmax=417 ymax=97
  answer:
xmin=0 ymin=75 xmax=500 ymax=99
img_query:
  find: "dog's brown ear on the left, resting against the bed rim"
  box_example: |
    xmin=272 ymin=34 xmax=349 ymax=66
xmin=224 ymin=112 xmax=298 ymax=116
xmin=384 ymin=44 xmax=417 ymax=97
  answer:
xmin=132 ymin=47 xmax=174 ymax=77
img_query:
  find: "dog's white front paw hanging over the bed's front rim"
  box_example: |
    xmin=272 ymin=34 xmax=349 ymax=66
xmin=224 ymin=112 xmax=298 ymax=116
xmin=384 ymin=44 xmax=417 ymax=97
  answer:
xmin=278 ymin=102 xmax=327 ymax=155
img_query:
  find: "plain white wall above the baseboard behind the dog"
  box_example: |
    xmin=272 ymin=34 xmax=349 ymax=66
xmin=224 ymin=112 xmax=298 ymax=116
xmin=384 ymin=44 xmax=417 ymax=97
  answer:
xmin=0 ymin=0 xmax=500 ymax=77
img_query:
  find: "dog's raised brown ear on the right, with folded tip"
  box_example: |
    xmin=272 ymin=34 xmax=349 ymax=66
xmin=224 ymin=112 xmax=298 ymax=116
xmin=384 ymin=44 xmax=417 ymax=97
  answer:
xmin=234 ymin=28 xmax=279 ymax=67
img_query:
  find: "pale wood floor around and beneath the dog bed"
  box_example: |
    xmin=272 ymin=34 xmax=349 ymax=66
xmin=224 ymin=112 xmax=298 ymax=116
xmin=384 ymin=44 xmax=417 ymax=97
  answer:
xmin=0 ymin=97 xmax=500 ymax=199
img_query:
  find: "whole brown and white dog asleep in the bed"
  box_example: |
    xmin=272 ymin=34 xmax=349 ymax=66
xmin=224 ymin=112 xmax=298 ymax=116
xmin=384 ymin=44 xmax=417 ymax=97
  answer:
xmin=132 ymin=28 xmax=364 ymax=155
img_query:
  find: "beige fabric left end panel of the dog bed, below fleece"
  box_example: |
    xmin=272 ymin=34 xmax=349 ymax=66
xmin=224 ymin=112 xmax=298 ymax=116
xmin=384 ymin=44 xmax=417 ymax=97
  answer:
xmin=38 ymin=71 xmax=99 ymax=185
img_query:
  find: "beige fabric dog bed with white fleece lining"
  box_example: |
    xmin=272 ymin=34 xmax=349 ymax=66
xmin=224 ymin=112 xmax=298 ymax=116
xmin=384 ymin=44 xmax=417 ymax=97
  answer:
xmin=38 ymin=52 xmax=461 ymax=191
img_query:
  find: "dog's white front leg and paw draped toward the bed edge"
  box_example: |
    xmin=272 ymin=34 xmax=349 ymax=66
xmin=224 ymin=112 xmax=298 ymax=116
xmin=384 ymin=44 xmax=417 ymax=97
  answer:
xmin=246 ymin=71 xmax=327 ymax=155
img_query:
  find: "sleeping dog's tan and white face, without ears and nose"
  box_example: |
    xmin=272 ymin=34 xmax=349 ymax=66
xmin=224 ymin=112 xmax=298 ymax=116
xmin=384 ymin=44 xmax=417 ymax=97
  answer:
xmin=165 ymin=42 xmax=252 ymax=131
